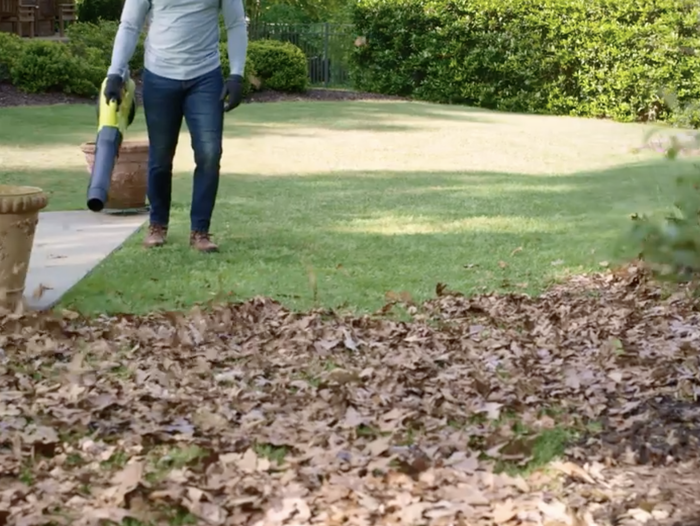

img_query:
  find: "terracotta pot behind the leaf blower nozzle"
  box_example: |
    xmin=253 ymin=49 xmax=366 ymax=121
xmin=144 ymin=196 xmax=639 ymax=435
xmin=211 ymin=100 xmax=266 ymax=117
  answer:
xmin=80 ymin=141 xmax=148 ymax=214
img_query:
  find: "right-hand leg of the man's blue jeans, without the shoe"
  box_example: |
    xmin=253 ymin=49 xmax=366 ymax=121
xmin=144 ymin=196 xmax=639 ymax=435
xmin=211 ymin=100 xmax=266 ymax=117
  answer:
xmin=184 ymin=68 xmax=224 ymax=232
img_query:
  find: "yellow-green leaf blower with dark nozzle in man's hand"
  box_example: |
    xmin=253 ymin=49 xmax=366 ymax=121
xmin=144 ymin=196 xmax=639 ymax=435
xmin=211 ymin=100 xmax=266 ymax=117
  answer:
xmin=87 ymin=70 xmax=136 ymax=212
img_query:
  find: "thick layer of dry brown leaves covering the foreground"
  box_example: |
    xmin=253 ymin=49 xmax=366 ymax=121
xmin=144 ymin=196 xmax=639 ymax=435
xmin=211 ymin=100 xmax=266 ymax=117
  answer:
xmin=0 ymin=267 xmax=700 ymax=526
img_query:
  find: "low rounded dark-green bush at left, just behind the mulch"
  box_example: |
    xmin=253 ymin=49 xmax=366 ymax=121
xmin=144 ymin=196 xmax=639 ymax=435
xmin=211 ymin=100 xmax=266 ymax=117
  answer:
xmin=10 ymin=40 xmax=104 ymax=96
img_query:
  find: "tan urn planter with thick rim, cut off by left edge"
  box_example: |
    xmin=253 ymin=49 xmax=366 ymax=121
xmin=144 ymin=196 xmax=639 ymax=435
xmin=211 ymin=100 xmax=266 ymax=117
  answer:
xmin=0 ymin=185 xmax=49 ymax=310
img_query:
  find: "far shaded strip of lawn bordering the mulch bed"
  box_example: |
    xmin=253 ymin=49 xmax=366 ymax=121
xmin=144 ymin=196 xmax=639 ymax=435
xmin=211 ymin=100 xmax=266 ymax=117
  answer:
xmin=0 ymin=101 xmax=496 ymax=147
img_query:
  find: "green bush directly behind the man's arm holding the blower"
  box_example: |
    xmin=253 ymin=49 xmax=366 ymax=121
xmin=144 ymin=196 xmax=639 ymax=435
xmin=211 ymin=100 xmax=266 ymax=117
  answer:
xmin=66 ymin=21 xmax=146 ymax=76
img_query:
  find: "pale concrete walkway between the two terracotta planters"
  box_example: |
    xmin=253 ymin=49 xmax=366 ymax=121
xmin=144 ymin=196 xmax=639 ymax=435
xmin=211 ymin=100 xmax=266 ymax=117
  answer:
xmin=24 ymin=210 xmax=148 ymax=310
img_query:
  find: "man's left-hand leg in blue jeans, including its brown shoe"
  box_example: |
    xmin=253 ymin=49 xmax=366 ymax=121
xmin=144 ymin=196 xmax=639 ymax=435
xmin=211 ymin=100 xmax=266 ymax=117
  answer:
xmin=143 ymin=70 xmax=185 ymax=247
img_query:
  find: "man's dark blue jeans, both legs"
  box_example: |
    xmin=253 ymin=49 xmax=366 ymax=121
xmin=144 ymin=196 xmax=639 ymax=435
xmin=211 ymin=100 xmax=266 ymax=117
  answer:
xmin=143 ymin=68 xmax=224 ymax=232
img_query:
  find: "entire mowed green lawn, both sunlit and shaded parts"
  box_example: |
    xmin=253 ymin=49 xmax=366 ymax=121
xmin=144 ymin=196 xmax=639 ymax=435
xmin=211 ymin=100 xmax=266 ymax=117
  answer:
xmin=0 ymin=102 xmax=693 ymax=313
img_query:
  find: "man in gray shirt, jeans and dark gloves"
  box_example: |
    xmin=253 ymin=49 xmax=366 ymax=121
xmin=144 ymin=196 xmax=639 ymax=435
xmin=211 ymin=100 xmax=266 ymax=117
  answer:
xmin=104 ymin=0 xmax=248 ymax=252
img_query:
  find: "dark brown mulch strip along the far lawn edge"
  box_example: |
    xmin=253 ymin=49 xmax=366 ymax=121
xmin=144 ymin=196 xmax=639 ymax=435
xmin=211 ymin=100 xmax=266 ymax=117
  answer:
xmin=0 ymin=83 xmax=401 ymax=108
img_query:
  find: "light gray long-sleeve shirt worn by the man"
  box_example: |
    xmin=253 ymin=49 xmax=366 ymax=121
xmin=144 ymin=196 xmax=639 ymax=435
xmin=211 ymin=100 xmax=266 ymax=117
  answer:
xmin=108 ymin=0 xmax=248 ymax=80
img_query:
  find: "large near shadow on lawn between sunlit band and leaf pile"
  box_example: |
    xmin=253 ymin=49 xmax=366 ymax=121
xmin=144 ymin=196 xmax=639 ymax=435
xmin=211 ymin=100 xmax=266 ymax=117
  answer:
xmin=50 ymin=158 xmax=692 ymax=313
